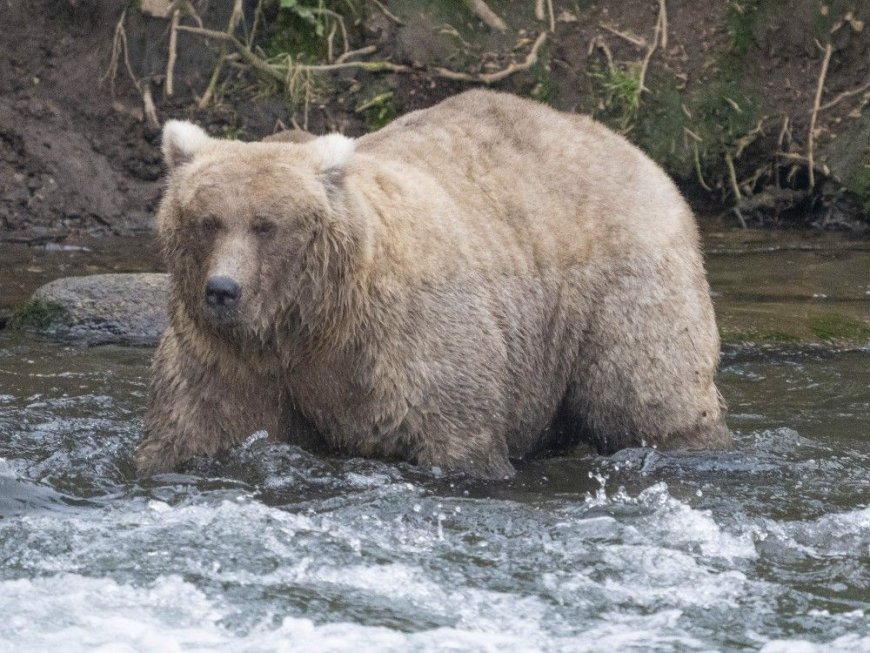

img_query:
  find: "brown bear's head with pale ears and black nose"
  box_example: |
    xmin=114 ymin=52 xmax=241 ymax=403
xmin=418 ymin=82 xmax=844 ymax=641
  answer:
xmin=157 ymin=121 xmax=365 ymax=343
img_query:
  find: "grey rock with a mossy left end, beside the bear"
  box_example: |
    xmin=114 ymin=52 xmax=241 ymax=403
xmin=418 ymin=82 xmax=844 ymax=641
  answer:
xmin=9 ymin=273 xmax=169 ymax=345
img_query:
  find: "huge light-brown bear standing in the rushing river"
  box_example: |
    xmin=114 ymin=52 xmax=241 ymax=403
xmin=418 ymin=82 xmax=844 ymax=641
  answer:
xmin=137 ymin=90 xmax=730 ymax=478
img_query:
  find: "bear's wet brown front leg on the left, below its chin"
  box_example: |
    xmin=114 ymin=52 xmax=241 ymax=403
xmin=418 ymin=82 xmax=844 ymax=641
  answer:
xmin=136 ymin=327 xmax=282 ymax=474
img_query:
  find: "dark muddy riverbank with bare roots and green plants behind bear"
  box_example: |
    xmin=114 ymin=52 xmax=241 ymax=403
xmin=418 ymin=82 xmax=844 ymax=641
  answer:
xmin=0 ymin=0 xmax=870 ymax=242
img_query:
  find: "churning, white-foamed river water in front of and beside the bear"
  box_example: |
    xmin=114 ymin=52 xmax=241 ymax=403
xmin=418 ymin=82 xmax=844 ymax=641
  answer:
xmin=0 ymin=232 xmax=870 ymax=653
